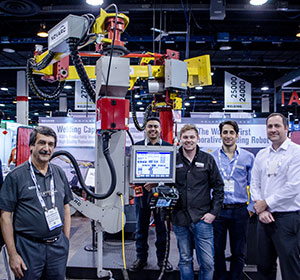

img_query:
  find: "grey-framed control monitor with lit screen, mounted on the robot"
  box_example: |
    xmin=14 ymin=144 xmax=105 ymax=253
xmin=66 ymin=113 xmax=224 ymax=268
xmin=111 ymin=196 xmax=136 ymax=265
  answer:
xmin=130 ymin=146 xmax=176 ymax=183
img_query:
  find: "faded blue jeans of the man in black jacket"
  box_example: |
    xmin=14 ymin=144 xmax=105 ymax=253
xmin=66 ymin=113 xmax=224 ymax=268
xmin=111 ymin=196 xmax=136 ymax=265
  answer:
xmin=173 ymin=221 xmax=214 ymax=280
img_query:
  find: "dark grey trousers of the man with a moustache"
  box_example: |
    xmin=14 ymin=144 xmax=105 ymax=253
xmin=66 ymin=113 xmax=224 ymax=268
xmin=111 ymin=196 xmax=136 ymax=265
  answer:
xmin=16 ymin=233 xmax=69 ymax=280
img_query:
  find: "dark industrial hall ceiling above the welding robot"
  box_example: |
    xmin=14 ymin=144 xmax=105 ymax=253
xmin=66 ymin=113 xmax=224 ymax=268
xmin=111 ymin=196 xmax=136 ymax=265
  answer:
xmin=0 ymin=0 xmax=300 ymax=123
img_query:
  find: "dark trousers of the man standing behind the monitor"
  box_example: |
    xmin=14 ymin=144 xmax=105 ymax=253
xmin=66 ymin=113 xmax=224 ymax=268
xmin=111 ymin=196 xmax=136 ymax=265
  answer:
xmin=135 ymin=195 xmax=167 ymax=261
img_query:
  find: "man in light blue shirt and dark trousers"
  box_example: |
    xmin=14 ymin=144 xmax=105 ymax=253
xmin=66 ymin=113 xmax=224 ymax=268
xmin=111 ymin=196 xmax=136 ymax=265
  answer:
xmin=213 ymin=121 xmax=254 ymax=280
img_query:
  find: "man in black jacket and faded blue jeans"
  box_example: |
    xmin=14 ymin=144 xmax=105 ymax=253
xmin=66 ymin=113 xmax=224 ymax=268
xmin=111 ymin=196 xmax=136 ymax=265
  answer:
xmin=172 ymin=124 xmax=224 ymax=280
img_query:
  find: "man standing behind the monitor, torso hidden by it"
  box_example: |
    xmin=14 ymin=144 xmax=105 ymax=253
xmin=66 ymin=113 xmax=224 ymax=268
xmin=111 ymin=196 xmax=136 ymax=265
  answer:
xmin=130 ymin=117 xmax=172 ymax=271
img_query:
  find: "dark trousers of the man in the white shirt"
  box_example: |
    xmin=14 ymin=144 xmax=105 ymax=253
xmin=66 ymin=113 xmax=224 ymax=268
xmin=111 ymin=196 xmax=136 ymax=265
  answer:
xmin=257 ymin=211 xmax=300 ymax=280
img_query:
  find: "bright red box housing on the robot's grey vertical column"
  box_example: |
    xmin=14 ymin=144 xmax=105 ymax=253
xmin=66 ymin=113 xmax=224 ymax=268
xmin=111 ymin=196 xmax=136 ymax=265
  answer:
xmin=97 ymin=97 xmax=129 ymax=130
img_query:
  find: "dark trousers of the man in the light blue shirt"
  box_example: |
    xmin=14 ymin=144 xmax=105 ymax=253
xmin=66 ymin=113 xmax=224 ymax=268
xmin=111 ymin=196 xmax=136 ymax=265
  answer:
xmin=213 ymin=206 xmax=250 ymax=280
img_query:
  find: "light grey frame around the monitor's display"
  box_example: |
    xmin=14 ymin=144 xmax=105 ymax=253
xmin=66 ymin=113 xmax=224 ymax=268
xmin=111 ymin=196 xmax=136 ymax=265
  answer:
xmin=130 ymin=145 xmax=177 ymax=184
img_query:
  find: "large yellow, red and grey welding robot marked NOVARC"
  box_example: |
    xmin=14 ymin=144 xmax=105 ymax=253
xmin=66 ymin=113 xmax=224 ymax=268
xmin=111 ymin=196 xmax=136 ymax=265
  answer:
xmin=26 ymin=4 xmax=211 ymax=278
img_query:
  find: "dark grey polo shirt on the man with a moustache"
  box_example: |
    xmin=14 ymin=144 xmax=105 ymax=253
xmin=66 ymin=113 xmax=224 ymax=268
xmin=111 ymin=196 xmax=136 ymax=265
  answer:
xmin=0 ymin=161 xmax=72 ymax=238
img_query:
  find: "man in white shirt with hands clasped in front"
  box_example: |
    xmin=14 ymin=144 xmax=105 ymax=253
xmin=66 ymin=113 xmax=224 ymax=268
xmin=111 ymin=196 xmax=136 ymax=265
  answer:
xmin=250 ymin=113 xmax=300 ymax=280
